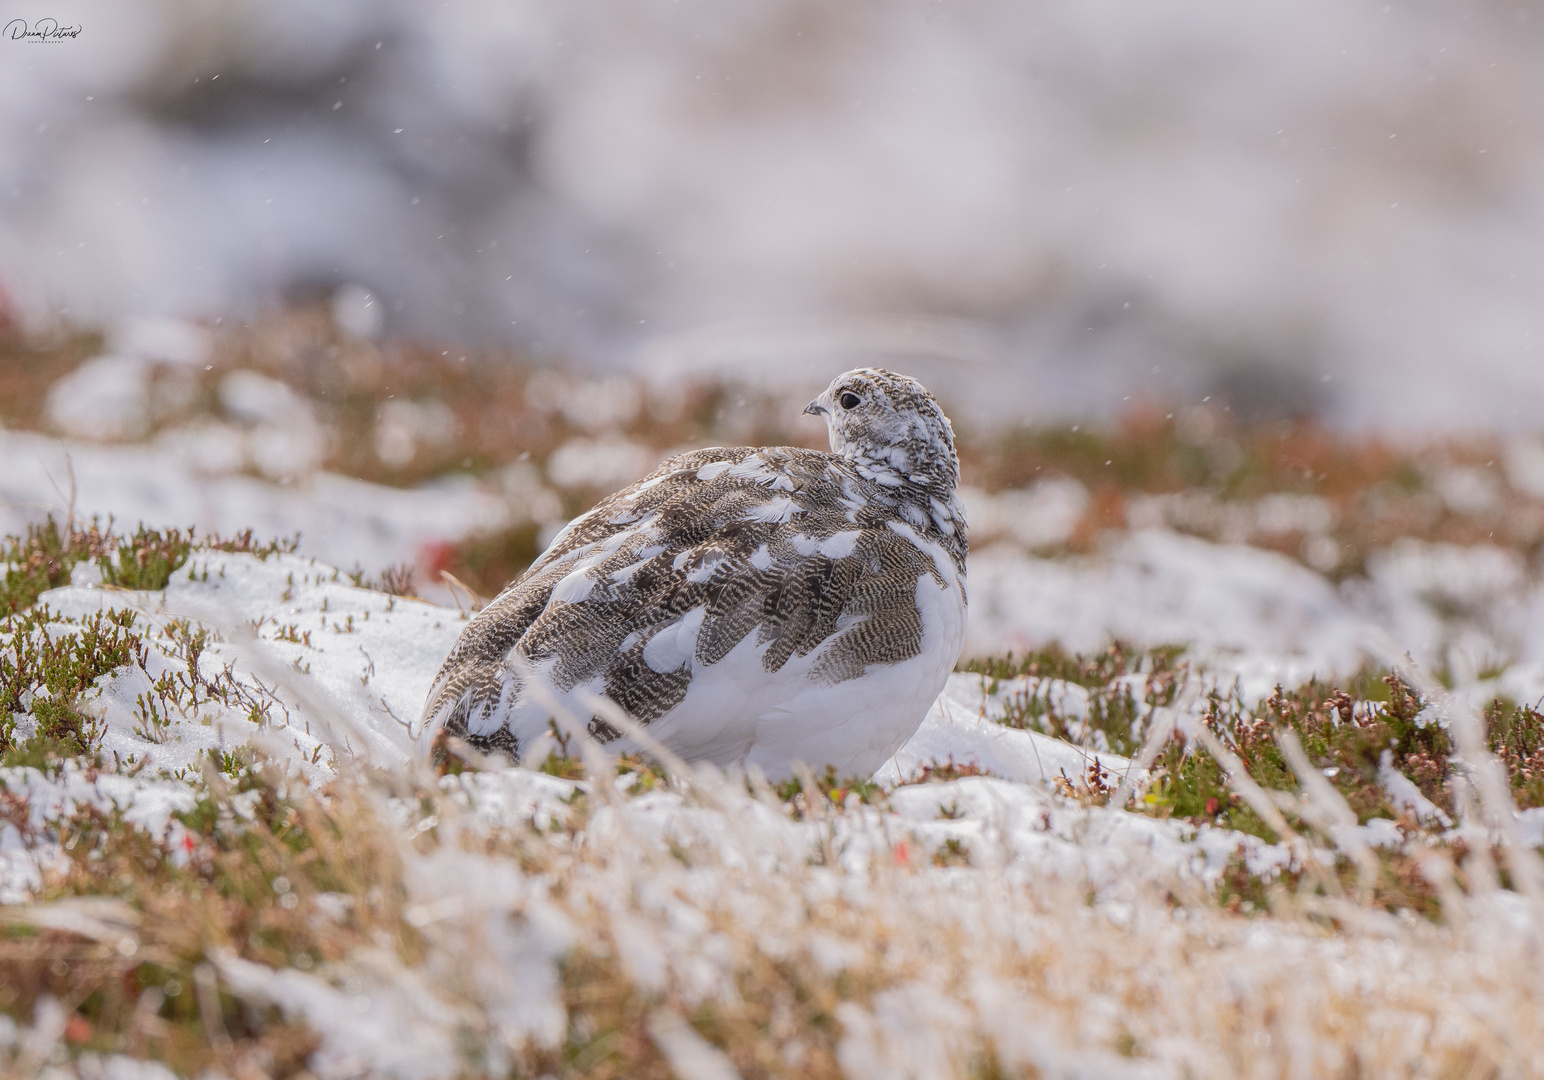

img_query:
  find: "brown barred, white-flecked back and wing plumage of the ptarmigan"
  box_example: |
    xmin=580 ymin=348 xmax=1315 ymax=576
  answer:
xmin=425 ymin=447 xmax=943 ymax=750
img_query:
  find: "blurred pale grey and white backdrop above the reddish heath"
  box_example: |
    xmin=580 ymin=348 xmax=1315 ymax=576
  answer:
xmin=9 ymin=0 xmax=1544 ymax=436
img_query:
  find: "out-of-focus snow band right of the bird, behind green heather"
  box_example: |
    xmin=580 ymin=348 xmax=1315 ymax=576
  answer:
xmin=965 ymin=528 xmax=1544 ymax=700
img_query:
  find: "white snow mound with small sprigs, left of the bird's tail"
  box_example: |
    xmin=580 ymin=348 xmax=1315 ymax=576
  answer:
xmin=39 ymin=552 xmax=466 ymax=776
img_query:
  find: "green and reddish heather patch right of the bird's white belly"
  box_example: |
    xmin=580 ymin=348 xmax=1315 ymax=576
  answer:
xmin=967 ymin=644 xmax=1544 ymax=841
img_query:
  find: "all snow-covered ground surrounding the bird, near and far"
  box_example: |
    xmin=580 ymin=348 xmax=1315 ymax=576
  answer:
xmin=9 ymin=335 xmax=1544 ymax=1080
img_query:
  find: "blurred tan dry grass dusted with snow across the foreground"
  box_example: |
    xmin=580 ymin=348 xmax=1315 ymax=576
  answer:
xmin=0 ymin=713 xmax=1544 ymax=1078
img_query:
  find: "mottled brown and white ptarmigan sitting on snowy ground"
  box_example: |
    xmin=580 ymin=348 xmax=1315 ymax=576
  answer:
xmin=423 ymin=368 xmax=965 ymax=779
